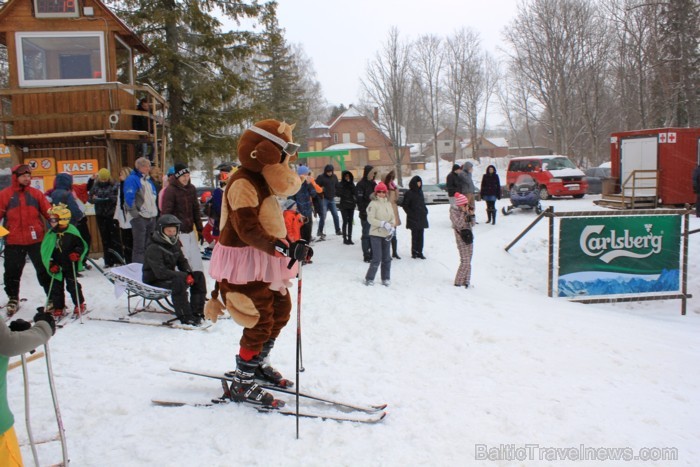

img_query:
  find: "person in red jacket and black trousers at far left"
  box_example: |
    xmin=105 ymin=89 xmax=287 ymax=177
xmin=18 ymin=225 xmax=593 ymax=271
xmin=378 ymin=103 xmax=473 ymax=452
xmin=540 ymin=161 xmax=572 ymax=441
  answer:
xmin=0 ymin=164 xmax=51 ymax=316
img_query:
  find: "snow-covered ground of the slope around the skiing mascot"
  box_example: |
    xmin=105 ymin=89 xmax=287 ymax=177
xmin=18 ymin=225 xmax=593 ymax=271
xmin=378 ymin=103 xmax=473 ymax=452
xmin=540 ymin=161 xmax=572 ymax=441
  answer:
xmin=8 ymin=165 xmax=700 ymax=466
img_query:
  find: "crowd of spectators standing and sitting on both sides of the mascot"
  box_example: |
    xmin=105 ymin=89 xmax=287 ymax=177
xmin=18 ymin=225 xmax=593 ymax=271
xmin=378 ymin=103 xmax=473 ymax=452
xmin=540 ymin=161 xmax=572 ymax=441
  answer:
xmin=0 ymin=157 xmax=492 ymax=325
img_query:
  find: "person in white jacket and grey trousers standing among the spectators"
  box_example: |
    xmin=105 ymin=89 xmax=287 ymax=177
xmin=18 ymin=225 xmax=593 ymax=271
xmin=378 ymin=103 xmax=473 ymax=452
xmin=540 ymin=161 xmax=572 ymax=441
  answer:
xmin=365 ymin=182 xmax=396 ymax=287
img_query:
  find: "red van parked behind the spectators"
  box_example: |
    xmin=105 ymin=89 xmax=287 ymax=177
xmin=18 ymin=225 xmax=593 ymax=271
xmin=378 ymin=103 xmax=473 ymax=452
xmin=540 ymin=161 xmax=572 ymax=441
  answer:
xmin=506 ymin=155 xmax=588 ymax=199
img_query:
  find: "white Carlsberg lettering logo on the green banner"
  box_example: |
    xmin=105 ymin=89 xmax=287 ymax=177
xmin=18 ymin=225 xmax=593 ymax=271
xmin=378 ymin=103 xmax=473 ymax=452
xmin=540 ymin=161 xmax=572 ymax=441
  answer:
xmin=579 ymin=224 xmax=663 ymax=263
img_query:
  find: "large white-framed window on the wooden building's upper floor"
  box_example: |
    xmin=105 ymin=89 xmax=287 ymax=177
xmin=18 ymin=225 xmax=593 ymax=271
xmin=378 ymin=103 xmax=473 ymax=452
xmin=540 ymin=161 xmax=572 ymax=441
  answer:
xmin=16 ymin=32 xmax=106 ymax=87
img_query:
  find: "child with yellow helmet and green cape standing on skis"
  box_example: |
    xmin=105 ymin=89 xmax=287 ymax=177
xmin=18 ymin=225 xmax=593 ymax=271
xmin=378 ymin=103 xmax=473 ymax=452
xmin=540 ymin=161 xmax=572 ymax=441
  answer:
xmin=41 ymin=203 xmax=88 ymax=319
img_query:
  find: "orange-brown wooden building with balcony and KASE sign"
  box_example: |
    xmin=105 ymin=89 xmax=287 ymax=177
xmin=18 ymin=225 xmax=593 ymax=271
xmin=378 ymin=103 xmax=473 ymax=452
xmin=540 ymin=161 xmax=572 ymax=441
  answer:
xmin=0 ymin=0 xmax=167 ymax=251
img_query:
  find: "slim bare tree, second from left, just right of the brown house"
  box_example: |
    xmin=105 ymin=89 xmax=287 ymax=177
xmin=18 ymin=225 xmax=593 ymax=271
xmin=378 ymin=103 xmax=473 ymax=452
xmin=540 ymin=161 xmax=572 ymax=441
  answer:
xmin=412 ymin=34 xmax=444 ymax=181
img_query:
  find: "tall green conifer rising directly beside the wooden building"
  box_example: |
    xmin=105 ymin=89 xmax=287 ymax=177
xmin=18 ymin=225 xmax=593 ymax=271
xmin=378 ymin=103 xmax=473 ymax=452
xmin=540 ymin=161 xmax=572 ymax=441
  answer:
xmin=105 ymin=0 xmax=264 ymax=165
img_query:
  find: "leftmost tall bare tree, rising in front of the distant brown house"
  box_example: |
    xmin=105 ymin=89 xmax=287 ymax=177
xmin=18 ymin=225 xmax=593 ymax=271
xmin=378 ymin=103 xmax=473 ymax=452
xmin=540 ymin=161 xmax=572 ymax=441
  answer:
xmin=362 ymin=27 xmax=410 ymax=185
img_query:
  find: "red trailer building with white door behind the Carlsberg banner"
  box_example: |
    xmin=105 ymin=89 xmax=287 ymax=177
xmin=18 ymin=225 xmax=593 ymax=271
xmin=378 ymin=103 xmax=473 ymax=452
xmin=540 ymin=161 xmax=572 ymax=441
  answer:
xmin=610 ymin=128 xmax=700 ymax=205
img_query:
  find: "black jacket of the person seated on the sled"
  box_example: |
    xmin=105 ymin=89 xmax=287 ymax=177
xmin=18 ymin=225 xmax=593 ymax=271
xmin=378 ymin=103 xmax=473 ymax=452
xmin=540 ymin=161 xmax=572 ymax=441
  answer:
xmin=143 ymin=228 xmax=192 ymax=285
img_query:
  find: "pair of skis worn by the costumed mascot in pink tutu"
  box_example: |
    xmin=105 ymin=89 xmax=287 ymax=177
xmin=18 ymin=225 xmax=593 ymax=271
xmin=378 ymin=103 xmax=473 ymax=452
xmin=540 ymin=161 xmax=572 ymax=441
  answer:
xmin=151 ymin=368 xmax=387 ymax=423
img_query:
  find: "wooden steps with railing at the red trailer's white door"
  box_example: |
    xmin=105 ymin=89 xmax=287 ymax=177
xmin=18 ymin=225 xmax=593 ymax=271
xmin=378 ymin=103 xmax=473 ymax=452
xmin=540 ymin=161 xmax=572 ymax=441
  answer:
xmin=594 ymin=170 xmax=659 ymax=209
